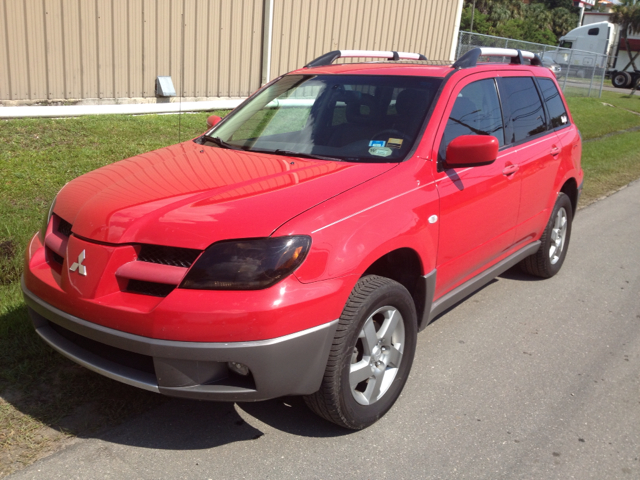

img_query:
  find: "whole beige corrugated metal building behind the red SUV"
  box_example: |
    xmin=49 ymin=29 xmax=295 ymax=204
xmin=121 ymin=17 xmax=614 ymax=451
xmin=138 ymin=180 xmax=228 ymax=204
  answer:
xmin=0 ymin=0 xmax=463 ymax=105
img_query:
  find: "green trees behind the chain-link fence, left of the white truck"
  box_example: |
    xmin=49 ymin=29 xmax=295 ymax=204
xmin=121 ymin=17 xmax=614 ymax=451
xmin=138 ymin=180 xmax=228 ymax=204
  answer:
xmin=461 ymin=0 xmax=578 ymax=45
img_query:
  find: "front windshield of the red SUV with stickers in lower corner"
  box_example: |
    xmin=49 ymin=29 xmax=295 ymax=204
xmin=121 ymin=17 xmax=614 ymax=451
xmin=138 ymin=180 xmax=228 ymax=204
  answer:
xmin=201 ymin=75 xmax=442 ymax=162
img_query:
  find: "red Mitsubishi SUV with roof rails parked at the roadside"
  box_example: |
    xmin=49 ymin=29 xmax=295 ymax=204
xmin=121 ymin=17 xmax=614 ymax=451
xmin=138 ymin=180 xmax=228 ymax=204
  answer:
xmin=22 ymin=49 xmax=583 ymax=429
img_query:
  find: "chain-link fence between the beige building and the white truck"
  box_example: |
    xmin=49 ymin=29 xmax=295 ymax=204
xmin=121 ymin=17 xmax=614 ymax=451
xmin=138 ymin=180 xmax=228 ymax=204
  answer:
xmin=456 ymin=32 xmax=607 ymax=97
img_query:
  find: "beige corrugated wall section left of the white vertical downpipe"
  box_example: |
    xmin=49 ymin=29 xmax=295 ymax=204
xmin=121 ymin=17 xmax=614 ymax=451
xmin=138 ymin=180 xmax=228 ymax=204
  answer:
xmin=0 ymin=0 xmax=263 ymax=100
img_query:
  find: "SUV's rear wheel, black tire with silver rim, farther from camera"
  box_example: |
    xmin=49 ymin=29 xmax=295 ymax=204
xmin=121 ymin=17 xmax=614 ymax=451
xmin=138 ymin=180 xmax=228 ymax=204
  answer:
xmin=520 ymin=192 xmax=573 ymax=278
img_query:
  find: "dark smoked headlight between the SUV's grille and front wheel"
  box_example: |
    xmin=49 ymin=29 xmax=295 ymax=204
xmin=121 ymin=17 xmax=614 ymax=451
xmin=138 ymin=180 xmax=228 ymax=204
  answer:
xmin=180 ymin=236 xmax=311 ymax=290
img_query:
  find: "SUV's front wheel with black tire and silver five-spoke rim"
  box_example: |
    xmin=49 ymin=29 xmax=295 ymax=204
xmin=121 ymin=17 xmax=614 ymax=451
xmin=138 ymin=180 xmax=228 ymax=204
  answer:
xmin=305 ymin=275 xmax=417 ymax=430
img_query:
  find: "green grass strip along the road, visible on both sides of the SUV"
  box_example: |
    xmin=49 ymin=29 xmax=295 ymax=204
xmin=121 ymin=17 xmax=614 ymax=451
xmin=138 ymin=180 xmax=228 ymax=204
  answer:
xmin=0 ymin=92 xmax=640 ymax=476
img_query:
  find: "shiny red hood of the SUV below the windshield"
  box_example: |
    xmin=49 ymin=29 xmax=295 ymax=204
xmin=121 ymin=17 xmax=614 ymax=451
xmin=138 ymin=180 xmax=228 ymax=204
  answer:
xmin=54 ymin=141 xmax=396 ymax=249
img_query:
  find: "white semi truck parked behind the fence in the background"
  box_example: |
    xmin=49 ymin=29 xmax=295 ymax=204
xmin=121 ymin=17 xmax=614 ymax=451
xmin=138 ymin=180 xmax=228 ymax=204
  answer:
xmin=544 ymin=18 xmax=640 ymax=88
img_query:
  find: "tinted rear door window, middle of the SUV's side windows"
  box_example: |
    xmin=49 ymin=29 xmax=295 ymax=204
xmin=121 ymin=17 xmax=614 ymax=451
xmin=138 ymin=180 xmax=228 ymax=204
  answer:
xmin=501 ymin=77 xmax=547 ymax=143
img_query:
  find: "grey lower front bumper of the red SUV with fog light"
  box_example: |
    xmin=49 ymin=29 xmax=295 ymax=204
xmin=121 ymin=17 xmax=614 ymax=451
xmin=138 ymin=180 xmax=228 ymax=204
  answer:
xmin=22 ymin=278 xmax=338 ymax=401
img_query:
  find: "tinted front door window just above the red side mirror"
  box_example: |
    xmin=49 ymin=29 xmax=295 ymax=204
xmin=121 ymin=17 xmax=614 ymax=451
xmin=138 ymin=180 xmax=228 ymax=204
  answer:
xmin=439 ymin=78 xmax=504 ymax=159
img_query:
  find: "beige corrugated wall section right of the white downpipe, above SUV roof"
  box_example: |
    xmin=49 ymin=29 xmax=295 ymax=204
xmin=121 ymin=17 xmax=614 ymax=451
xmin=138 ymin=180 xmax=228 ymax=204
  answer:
xmin=271 ymin=0 xmax=462 ymax=78
